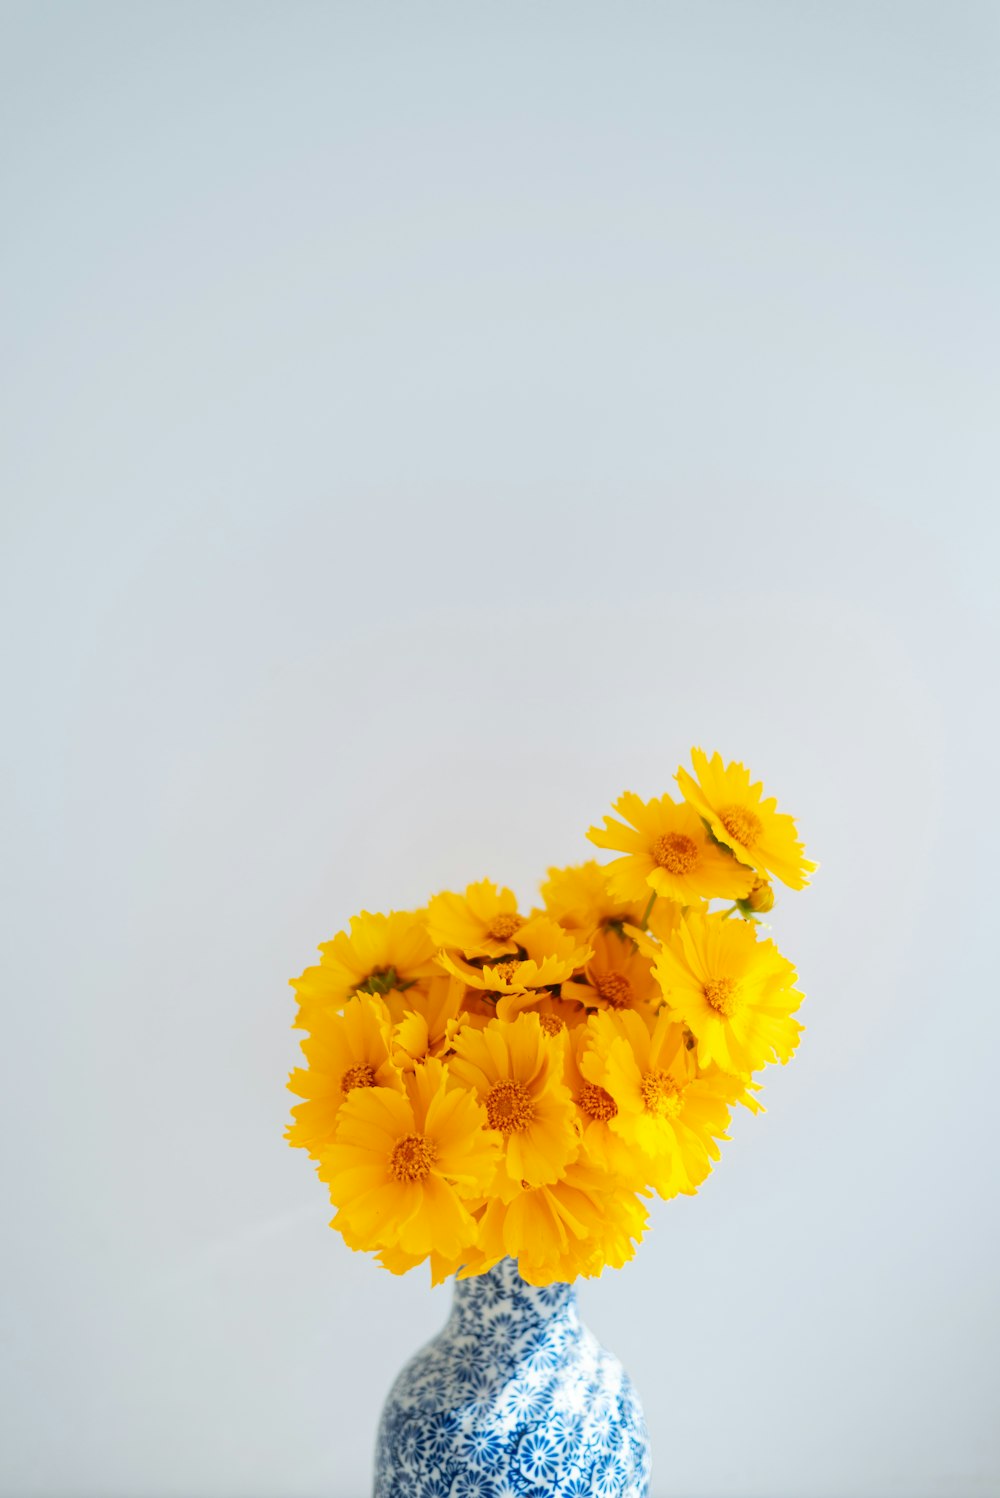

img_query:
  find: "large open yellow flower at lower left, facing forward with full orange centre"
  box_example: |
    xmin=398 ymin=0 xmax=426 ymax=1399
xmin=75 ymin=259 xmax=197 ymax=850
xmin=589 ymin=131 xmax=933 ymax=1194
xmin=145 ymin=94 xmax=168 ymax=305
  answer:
xmin=319 ymin=1061 xmax=499 ymax=1260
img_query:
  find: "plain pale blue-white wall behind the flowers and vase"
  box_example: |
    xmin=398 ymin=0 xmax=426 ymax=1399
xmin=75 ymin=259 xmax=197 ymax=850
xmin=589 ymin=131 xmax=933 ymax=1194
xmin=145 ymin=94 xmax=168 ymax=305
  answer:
xmin=0 ymin=0 xmax=1000 ymax=1498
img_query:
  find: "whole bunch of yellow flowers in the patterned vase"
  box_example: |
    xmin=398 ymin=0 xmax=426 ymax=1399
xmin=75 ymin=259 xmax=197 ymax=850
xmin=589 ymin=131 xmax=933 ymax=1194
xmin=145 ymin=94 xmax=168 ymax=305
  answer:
xmin=287 ymin=749 xmax=816 ymax=1285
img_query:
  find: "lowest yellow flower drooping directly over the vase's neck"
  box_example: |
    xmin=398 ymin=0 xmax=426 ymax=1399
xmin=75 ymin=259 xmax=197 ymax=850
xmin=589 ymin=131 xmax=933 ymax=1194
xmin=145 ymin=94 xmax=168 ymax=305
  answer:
xmin=458 ymin=1164 xmax=647 ymax=1285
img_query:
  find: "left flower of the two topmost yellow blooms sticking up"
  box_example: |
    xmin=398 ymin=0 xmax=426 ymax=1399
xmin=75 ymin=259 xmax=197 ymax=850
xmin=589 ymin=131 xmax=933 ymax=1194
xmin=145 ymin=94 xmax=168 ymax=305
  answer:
xmin=587 ymin=791 xmax=753 ymax=905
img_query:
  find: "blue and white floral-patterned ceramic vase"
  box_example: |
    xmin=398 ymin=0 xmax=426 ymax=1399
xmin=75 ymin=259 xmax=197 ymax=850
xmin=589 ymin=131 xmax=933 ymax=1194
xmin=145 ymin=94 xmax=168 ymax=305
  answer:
xmin=374 ymin=1258 xmax=650 ymax=1498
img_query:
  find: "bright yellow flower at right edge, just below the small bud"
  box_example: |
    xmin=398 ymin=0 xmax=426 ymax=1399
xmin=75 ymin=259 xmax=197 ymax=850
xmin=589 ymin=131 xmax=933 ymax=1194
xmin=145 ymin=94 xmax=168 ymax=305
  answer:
xmin=656 ymin=912 xmax=802 ymax=1076
